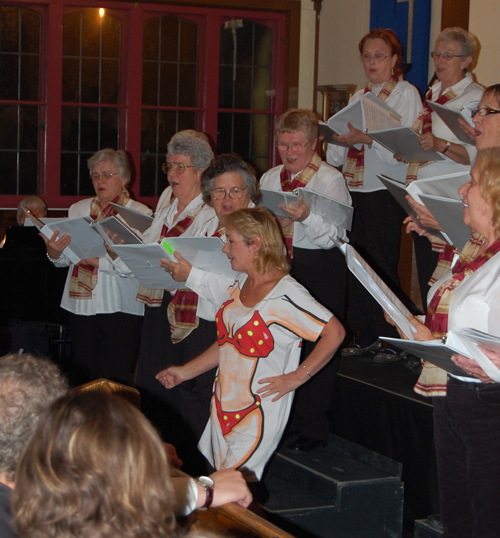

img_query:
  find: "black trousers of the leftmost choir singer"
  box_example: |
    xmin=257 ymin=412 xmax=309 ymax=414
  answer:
xmin=69 ymin=312 xmax=142 ymax=385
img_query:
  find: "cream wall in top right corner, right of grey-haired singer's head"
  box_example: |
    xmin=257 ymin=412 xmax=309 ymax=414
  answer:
xmin=469 ymin=0 xmax=500 ymax=86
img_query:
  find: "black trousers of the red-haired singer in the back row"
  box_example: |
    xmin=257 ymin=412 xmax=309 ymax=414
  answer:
xmin=348 ymin=190 xmax=406 ymax=338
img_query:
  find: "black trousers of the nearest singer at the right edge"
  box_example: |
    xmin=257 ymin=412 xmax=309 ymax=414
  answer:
xmin=433 ymin=376 xmax=500 ymax=538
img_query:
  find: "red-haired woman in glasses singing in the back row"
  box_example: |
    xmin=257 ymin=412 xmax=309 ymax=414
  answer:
xmin=327 ymin=28 xmax=422 ymax=361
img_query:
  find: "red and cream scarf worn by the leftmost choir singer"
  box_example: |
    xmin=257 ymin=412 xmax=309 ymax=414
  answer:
xmin=69 ymin=190 xmax=130 ymax=299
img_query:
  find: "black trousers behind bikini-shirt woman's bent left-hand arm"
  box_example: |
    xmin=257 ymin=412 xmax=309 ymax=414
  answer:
xmin=136 ymin=292 xmax=217 ymax=474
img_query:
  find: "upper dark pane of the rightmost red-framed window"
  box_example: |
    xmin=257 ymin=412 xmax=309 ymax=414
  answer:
xmin=219 ymin=20 xmax=273 ymax=110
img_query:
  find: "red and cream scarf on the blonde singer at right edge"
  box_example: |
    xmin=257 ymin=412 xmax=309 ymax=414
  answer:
xmin=414 ymin=233 xmax=500 ymax=396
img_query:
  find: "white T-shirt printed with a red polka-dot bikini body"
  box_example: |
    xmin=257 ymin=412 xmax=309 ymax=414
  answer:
xmin=199 ymin=275 xmax=332 ymax=479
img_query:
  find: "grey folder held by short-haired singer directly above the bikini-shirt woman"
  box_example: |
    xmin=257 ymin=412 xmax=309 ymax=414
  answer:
xmin=260 ymin=188 xmax=354 ymax=230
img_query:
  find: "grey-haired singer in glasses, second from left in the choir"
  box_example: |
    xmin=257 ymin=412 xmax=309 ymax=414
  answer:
xmin=136 ymin=130 xmax=215 ymax=471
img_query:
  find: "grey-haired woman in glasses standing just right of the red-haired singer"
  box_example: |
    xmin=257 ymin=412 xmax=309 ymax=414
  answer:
xmin=400 ymin=28 xmax=484 ymax=305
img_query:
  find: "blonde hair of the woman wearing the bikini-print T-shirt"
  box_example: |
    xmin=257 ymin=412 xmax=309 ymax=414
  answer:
xmin=224 ymin=207 xmax=290 ymax=275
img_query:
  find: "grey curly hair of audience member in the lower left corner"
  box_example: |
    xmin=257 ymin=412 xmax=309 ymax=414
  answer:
xmin=0 ymin=354 xmax=68 ymax=482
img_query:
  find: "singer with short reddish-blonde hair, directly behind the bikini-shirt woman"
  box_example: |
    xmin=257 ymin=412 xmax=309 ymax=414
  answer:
xmin=260 ymin=109 xmax=351 ymax=451
